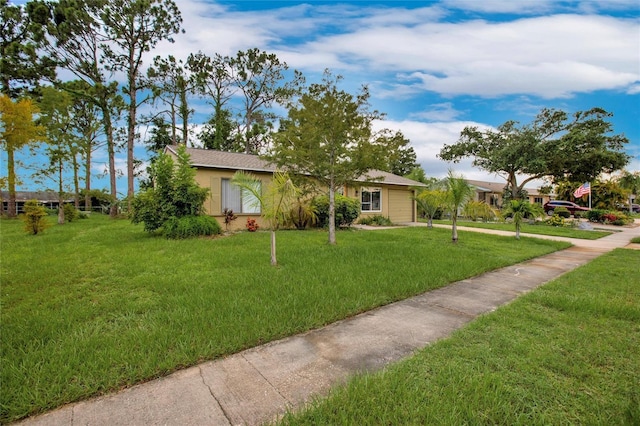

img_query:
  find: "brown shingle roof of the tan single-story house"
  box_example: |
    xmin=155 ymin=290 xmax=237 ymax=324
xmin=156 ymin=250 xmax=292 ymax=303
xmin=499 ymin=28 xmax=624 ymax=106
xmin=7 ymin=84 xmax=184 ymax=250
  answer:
xmin=166 ymin=146 xmax=424 ymax=186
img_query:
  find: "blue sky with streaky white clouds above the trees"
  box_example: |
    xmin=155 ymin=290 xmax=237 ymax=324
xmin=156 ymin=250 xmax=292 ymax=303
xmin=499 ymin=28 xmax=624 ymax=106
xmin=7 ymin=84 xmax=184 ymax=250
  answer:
xmin=8 ymin=0 xmax=640 ymax=191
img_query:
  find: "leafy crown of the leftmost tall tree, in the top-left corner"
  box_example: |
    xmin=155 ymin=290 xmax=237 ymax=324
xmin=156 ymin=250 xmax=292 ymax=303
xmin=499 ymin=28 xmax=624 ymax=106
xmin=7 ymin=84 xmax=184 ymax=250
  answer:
xmin=0 ymin=0 xmax=56 ymax=99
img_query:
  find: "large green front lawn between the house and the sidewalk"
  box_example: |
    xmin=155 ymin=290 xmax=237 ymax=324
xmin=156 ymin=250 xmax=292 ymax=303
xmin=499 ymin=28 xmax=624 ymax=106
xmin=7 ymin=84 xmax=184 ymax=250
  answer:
xmin=0 ymin=216 xmax=568 ymax=423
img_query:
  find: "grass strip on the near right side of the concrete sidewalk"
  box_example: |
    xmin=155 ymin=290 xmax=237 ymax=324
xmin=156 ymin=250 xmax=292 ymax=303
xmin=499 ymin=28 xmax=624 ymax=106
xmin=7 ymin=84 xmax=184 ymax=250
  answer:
xmin=282 ymin=249 xmax=640 ymax=425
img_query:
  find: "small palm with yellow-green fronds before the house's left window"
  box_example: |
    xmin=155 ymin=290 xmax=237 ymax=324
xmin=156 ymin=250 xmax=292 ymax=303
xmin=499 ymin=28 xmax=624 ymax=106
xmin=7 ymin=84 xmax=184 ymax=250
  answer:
xmin=231 ymin=171 xmax=299 ymax=266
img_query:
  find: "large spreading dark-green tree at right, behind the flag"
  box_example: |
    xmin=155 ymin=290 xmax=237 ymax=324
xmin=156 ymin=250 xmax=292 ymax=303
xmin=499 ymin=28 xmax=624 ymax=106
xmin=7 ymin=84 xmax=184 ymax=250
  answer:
xmin=439 ymin=108 xmax=629 ymax=199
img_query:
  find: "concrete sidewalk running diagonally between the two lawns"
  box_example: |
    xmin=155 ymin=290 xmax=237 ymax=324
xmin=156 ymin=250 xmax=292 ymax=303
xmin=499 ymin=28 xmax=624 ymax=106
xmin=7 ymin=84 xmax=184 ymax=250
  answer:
xmin=19 ymin=223 xmax=640 ymax=426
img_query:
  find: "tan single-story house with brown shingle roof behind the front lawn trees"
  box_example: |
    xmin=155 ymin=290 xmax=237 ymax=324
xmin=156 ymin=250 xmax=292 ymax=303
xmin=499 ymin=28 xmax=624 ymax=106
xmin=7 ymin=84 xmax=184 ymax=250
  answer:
xmin=165 ymin=146 xmax=423 ymax=229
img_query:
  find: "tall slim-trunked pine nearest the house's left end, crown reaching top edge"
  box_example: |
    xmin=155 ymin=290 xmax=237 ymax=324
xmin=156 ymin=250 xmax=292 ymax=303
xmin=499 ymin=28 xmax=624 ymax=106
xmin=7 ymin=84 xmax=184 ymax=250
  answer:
xmin=100 ymin=0 xmax=182 ymax=210
